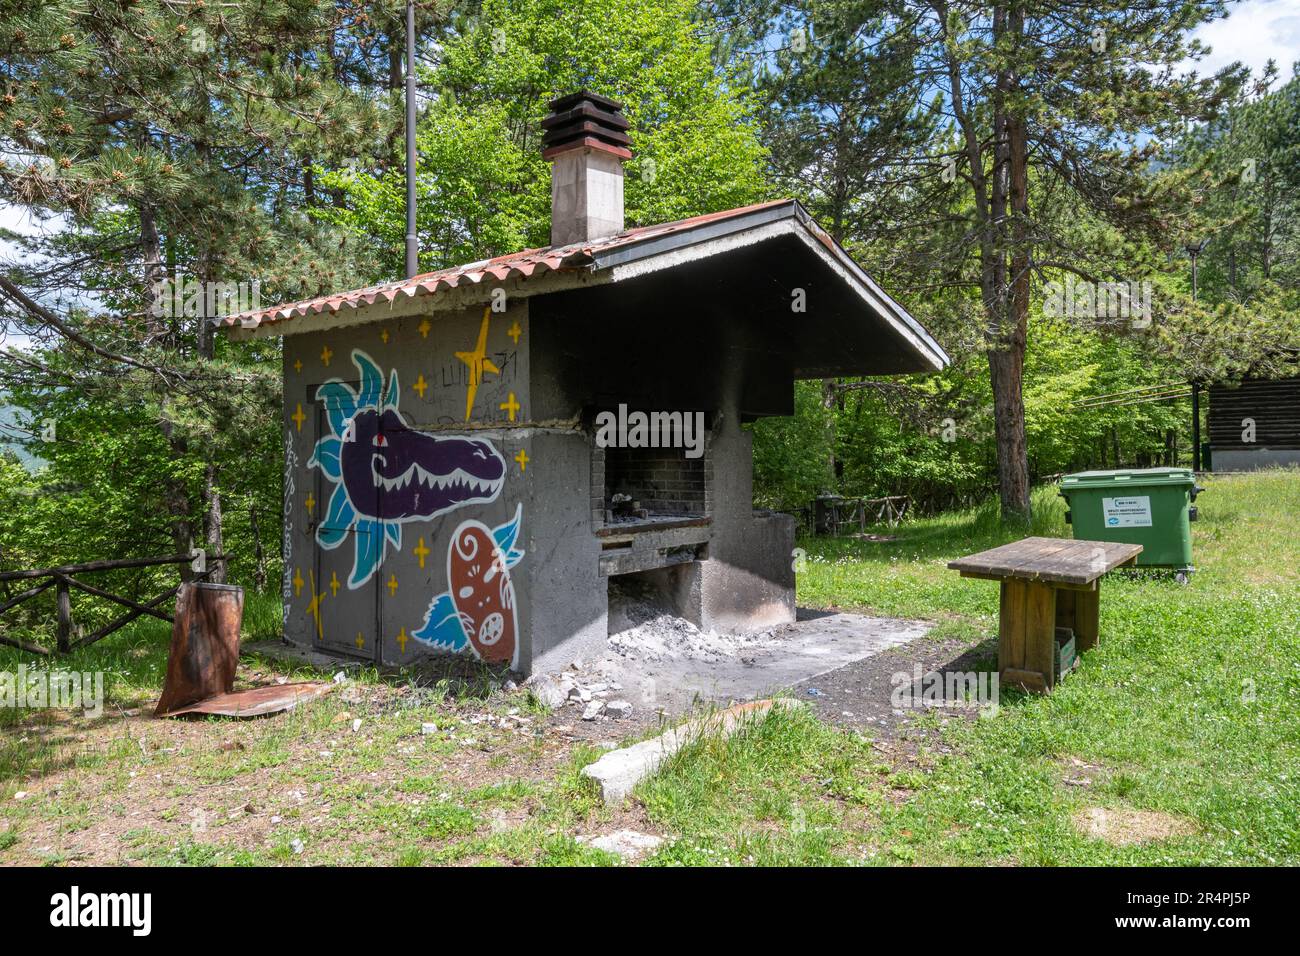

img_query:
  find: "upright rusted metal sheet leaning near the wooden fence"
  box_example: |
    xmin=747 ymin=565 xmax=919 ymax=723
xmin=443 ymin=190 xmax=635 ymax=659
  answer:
xmin=153 ymin=581 xmax=243 ymax=714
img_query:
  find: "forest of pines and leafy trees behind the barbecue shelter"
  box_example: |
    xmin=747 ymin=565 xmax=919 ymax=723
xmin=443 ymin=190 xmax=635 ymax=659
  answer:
xmin=0 ymin=0 xmax=1300 ymax=621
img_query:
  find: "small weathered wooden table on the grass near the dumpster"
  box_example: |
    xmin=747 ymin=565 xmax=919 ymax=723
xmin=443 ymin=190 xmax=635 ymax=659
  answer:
xmin=948 ymin=537 xmax=1141 ymax=693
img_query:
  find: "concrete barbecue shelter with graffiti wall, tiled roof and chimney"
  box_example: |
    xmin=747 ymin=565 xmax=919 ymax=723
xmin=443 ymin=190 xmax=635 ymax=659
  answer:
xmin=220 ymin=94 xmax=948 ymax=674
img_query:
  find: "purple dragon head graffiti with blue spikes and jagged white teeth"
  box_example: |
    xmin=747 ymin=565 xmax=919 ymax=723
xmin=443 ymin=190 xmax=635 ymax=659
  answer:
xmin=308 ymin=349 xmax=506 ymax=589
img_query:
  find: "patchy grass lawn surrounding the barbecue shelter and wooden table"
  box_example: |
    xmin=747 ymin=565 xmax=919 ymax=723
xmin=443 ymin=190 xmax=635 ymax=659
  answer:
xmin=0 ymin=471 xmax=1300 ymax=865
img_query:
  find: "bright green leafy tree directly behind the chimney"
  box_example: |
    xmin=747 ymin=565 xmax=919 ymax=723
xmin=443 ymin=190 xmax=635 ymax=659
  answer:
xmin=319 ymin=0 xmax=768 ymax=278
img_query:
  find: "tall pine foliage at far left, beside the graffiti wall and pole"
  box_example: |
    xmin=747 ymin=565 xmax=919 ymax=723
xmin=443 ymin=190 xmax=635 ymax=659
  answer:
xmin=0 ymin=0 xmax=421 ymax=574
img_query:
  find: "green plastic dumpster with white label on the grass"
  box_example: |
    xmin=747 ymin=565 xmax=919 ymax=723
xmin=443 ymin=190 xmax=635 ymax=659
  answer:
xmin=1061 ymin=468 xmax=1201 ymax=574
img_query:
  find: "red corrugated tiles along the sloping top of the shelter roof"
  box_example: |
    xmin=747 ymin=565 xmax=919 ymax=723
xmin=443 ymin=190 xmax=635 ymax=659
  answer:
xmin=216 ymin=199 xmax=794 ymax=329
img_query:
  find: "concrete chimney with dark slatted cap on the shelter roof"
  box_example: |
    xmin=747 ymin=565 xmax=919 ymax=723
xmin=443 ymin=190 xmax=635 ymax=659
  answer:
xmin=542 ymin=91 xmax=632 ymax=246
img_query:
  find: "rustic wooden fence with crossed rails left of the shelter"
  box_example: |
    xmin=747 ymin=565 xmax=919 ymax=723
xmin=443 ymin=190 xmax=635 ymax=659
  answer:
xmin=0 ymin=554 xmax=226 ymax=654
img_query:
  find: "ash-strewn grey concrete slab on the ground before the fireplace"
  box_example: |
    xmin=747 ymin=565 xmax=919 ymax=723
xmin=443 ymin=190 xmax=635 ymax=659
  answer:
xmin=576 ymin=610 xmax=931 ymax=715
